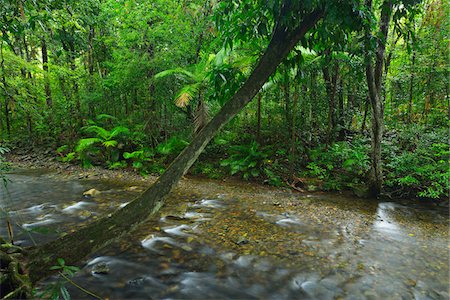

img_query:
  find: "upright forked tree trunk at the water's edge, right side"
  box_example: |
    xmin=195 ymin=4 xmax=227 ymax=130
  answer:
xmin=365 ymin=0 xmax=393 ymax=197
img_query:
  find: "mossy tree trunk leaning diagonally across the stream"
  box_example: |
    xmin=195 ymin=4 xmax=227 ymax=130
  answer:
xmin=27 ymin=10 xmax=323 ymax=282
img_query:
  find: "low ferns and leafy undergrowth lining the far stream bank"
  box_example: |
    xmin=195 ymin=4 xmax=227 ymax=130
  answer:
xmin=44 ymin=115 xmax=450 ymax=199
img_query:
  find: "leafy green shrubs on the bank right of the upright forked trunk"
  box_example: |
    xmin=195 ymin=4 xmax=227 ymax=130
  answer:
xmin=385 ymin=125 xmax=450 ymax=198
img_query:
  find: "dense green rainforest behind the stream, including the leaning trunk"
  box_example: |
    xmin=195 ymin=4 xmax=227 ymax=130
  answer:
xmin=0 ymin=0 xmax=450 ymax=298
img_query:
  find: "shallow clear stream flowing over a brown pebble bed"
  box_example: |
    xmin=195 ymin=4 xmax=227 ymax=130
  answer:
xmin=0 ymin=170 xmax=449 ymax=299
